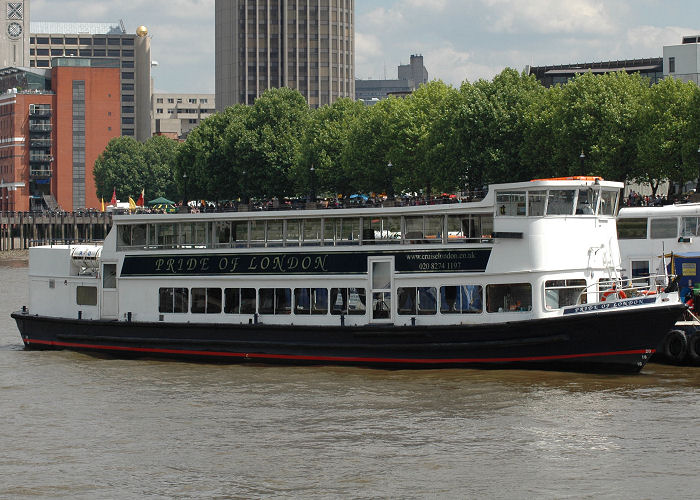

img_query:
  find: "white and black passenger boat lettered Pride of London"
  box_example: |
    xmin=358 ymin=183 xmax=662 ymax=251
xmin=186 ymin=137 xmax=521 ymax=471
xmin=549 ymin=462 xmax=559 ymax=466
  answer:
xmin=12 ymin=178 xmax=684 ymax=372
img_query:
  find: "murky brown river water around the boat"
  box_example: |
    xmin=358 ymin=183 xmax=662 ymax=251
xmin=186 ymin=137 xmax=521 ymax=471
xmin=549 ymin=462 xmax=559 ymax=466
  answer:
xmin=0 ymin=262 xmax=700 ymax=499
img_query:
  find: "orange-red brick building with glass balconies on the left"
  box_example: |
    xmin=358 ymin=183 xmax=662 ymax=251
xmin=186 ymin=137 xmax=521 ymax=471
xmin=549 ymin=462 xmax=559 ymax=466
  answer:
xmin=0 ymin=57 xmax=121 ymax=211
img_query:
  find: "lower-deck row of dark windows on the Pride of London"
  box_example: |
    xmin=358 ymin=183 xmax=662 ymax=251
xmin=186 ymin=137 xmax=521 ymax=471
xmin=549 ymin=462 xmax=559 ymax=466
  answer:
xmin=158 ymin=282 xmax=548 ymax=316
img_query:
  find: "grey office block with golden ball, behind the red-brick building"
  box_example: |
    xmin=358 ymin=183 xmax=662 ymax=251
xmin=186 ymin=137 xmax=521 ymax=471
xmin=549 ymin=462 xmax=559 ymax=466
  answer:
xmin=25 ymin=20 xmax=151 ymax=141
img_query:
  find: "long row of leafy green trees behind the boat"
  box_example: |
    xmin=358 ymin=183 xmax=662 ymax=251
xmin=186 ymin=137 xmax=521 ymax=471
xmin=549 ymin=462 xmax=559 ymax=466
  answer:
xmin=95 ymin=69 xmax=700 ymax=200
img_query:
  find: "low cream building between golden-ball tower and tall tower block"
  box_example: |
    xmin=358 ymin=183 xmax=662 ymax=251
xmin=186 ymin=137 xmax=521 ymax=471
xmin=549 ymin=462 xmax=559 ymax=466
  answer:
xmin=151 ymin=94 xmax=216 ymax=139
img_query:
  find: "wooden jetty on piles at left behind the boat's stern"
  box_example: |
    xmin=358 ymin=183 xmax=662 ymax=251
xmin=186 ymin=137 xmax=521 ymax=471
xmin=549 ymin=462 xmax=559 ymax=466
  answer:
xmin=0 ymin=211 xmax=112 ymax=251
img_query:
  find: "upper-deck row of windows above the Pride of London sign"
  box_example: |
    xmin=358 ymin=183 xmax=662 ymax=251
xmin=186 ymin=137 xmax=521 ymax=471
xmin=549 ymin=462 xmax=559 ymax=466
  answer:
xmin=117 ymin=214 xmax=493 ymax=250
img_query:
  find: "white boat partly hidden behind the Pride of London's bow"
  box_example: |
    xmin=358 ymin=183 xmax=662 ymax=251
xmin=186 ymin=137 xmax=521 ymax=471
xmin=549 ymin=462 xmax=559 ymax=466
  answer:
xmin=617 ymin=203 xmax=700 ymax=365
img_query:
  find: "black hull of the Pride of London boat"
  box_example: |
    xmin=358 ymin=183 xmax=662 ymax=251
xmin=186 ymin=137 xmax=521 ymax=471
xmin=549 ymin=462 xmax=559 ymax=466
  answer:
xmin=12 ymin=304 xmax=684 ymax=373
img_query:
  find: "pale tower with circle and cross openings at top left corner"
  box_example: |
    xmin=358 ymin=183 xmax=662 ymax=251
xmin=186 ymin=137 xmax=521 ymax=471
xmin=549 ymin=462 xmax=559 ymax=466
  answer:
xmin=0 ymin=0 xmax=29 ymax=68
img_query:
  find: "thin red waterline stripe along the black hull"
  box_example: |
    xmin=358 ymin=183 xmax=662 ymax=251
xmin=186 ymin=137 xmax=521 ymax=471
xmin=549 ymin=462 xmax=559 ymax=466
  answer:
xmin=24 ymin=339 xmax=656 ymax=365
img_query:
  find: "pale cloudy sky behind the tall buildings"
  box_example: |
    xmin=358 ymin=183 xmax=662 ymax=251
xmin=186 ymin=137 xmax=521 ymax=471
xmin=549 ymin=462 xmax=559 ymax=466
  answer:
xmin=30 ymin=0 xmax=700 ymax=93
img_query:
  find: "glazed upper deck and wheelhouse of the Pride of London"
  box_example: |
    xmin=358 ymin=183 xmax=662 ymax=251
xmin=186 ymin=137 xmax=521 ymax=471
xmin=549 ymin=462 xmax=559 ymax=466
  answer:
xmin=105 ymin=178 xmax=623 ymax=252
